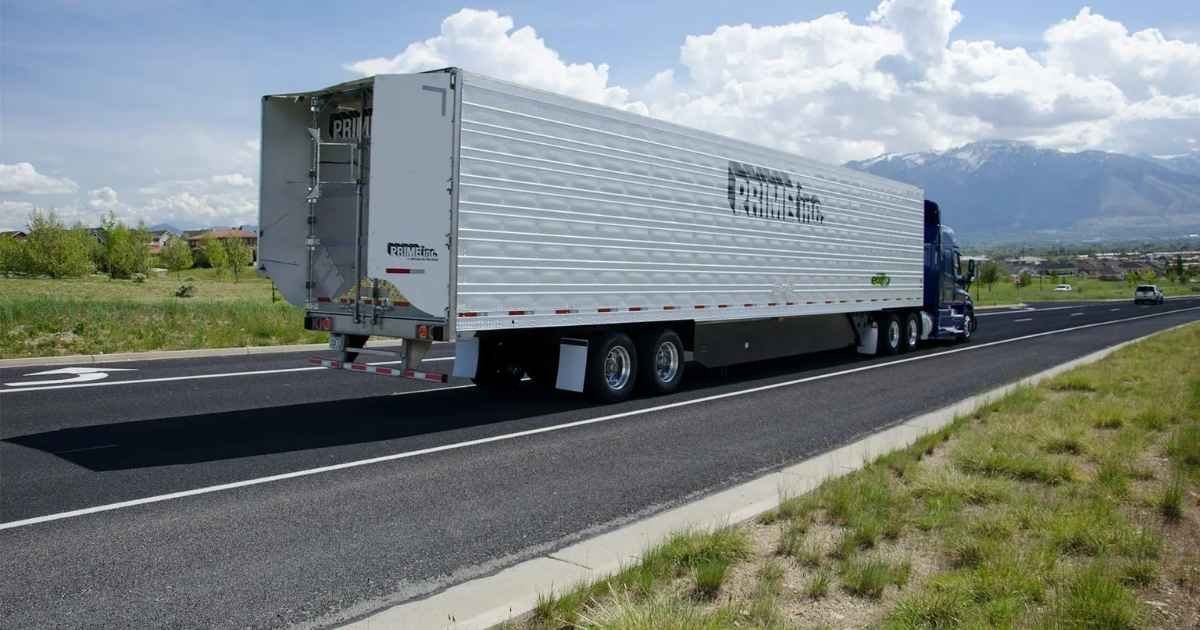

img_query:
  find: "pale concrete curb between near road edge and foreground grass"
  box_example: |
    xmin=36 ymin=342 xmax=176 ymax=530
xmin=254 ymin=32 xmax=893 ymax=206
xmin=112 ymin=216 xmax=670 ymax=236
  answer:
xmin=343 ymin=323 xmax=1192 ymax=630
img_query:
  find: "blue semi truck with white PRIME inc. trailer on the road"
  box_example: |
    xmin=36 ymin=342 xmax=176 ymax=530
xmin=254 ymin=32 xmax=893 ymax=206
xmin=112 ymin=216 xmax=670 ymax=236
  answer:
xmin=258 ymin=67 xmax=977 ymax=402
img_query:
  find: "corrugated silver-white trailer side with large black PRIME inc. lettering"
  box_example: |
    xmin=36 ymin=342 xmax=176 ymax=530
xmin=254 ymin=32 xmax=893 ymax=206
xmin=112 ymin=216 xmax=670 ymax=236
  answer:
xmin=454 ymin=72 xmax=924 ymax=332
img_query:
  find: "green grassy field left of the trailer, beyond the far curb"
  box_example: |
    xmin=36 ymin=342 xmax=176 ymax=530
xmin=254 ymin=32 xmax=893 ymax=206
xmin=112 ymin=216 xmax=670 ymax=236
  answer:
xmin=0 ymin=269 xmax=328 ymax=358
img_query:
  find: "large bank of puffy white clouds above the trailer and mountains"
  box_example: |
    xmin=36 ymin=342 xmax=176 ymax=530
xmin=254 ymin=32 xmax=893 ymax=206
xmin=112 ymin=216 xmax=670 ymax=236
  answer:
xmin=347 ymin=0 xmax=1200 ymax=161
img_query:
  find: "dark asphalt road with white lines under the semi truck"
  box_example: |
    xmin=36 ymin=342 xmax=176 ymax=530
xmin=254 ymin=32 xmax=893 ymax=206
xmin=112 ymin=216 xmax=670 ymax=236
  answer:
xmin=0 ymin=299 xmax=1200 ymax=629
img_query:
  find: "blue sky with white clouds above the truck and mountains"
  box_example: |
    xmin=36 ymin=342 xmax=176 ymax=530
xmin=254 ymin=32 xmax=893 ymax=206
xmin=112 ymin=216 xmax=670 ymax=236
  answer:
xmin=0 ymin=0 xmax=1200 ymax=227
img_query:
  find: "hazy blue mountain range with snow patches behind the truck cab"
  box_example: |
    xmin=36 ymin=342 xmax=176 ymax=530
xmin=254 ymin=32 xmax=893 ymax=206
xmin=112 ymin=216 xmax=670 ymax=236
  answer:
xmin=846 ymin=140 xmax=1200 ymax=242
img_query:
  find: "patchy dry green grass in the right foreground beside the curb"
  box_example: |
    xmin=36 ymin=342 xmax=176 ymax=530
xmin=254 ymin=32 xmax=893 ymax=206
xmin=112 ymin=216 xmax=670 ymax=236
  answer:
xmin=523 ymin=324 xmax=1200 ymax=630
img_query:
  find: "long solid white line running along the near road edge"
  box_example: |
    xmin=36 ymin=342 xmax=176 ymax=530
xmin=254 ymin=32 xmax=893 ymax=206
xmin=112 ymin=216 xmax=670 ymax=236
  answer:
xmin=0 ymin=306 xmax=1200 ymax=530
